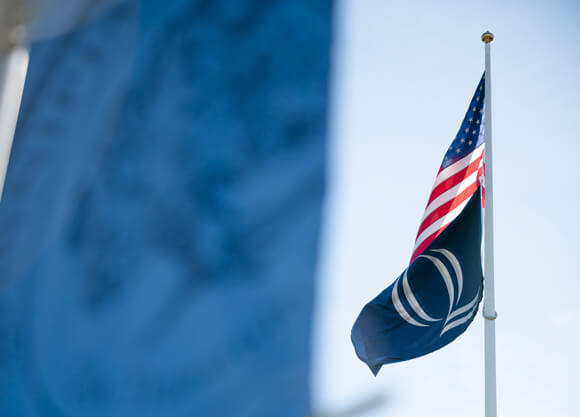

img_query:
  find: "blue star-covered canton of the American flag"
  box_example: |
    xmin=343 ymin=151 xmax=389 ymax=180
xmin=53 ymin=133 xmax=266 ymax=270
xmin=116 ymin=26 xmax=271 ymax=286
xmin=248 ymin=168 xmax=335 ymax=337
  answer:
xmin=441 ymin=73 xmax=485 ymax=170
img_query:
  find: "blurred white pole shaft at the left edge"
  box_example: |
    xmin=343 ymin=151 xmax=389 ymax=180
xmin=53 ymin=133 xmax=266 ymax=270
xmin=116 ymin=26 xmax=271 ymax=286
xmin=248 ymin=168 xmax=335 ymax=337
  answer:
xmin=0 ymin=46 xmax=28 ymax=199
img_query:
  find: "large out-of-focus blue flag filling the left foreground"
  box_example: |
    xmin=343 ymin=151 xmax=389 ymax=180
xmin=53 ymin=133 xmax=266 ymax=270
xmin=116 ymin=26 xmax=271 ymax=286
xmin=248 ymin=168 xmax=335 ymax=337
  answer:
xmin=0 ymin=0 xmax=333 ymax=417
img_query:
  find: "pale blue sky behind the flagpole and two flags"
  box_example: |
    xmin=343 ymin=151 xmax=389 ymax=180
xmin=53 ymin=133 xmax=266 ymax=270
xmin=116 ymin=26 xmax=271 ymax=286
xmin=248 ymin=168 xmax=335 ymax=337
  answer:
xmin=312 ymin=0 xmax=580 ymax=417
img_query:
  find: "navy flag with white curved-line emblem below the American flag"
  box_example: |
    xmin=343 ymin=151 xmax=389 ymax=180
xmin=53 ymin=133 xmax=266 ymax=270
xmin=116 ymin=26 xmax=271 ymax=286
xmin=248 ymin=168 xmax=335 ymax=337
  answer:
xmin=351 ymin=189 xmax=483 ymax=375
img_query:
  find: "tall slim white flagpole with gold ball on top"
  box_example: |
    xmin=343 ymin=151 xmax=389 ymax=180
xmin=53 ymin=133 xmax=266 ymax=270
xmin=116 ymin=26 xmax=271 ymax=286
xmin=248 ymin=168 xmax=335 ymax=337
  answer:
xmin=481 ymin=32 xmax=497 ymax=417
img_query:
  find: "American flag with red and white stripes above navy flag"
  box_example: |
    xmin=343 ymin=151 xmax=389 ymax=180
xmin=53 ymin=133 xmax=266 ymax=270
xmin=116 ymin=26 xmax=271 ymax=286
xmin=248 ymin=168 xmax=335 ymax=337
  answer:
xmin=411 ymin=74 xmax=485 ymax=262
